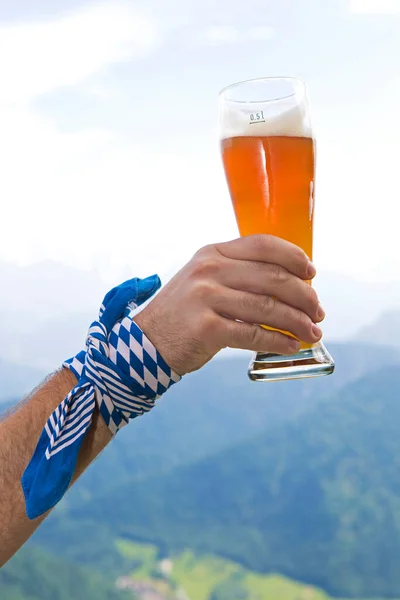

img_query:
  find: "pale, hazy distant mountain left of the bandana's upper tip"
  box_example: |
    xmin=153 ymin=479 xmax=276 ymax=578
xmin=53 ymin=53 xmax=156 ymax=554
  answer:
xmin=0 ymin=261 xmax=108 ymax=372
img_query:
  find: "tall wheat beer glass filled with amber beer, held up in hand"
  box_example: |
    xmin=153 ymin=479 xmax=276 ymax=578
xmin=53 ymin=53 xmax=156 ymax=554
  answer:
xmin=219 ymin=78 xmax=335 ymax=381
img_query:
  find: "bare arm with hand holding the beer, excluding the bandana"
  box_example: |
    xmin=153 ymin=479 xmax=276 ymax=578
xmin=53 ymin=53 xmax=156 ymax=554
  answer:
xmin=0 ymin=235 xmax=324 ymax=565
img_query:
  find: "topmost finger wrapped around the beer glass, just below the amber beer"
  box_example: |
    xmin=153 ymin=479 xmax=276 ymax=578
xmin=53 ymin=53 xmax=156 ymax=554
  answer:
xmin=215 ymin=235 xmax=316 ymax=280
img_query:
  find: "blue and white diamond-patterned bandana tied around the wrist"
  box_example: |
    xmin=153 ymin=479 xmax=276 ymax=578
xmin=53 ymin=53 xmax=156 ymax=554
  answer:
xmin=22 ymin=275 xmax=181 ymax=519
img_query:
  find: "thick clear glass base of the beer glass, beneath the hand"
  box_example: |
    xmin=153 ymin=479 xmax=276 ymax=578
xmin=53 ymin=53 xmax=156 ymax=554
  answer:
xmin=248 ymin=342 xmax=335 ymax=381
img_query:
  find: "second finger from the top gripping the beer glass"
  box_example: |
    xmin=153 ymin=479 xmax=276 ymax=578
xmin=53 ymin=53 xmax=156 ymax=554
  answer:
xmin=219 ymin=259 xmax=325 ymax=323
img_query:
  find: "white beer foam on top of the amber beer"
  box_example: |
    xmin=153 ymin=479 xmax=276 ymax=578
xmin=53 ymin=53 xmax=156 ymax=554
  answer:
xmin=220 ymin=97 xmax=312 ymax=139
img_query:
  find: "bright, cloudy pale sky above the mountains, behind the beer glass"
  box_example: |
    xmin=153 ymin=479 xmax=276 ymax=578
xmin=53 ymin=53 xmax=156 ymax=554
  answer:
xmin=0 ymin=0 xmax=400 ymax=282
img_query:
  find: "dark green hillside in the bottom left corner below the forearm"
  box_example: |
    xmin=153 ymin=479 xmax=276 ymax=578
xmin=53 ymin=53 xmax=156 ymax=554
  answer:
xmin=0 ymin=546 xmax=128 ymax=600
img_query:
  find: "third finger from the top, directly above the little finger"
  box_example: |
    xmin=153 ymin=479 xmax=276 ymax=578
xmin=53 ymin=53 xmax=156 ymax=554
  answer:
xmin=212 ymin=288 xmax=322 ymax=344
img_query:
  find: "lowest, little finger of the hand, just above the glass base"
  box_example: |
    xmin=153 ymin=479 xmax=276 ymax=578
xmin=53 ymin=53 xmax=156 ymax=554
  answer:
xmin=221 ymin=319 xmax=300 ymax=354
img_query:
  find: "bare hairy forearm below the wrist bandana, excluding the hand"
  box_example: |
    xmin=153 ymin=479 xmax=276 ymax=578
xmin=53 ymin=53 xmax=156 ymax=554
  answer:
xmin=0 ymin=369 xmax=111 ymax=566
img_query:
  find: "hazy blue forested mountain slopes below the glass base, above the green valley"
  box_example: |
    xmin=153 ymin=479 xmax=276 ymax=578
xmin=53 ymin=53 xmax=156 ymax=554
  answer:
xmin=8 ymin=347 xmax=400 ymax=597
